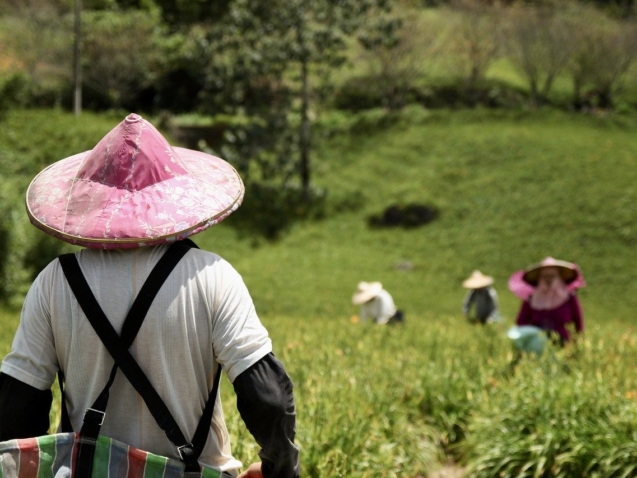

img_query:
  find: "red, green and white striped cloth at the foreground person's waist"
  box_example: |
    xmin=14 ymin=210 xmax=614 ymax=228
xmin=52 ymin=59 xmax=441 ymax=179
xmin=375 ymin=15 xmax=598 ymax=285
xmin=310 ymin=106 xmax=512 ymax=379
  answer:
xmin=0 ymin=433 xmax=222 ymax=478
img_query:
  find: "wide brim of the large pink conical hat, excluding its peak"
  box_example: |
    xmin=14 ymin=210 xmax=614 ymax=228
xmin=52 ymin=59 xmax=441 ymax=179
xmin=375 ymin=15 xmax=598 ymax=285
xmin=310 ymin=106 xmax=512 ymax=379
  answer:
xmin=26 ymin=147 xmax=244 ymax=249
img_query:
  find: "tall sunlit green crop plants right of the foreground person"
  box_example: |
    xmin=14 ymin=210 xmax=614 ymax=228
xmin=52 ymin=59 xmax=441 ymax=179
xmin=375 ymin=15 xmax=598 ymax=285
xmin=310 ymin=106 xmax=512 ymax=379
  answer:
xmin=232 ymin=316 xmax=637 ymax=477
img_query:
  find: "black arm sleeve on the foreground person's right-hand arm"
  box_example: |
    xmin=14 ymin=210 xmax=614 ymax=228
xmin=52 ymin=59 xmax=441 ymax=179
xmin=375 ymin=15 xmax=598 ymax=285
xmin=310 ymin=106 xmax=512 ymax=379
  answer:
xmin=233 ymin=353 xmax=300 ymax=478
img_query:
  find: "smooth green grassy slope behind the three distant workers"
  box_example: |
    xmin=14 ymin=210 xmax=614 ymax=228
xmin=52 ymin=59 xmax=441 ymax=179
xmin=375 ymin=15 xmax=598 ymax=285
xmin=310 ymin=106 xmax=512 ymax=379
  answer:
xmin=190 ymin=107 xmax=637 ymax=328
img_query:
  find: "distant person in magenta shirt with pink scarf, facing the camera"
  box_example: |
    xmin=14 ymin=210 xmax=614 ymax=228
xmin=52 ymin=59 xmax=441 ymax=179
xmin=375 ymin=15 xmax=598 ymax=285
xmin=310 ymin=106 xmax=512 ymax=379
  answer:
xmin=509 ymin=257 xmax=585 ymax=344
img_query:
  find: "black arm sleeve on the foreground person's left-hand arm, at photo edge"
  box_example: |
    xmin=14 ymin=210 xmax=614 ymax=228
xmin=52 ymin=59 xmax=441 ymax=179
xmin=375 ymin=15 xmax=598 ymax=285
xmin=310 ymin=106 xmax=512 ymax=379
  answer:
xmin=0 ymin=373 xmax=53 ymax=441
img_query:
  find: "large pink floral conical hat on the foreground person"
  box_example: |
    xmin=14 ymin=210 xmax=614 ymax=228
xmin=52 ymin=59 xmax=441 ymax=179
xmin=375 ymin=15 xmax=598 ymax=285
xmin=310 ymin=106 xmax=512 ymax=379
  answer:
xmin=26 ymin=114 xmax=244 ymax=249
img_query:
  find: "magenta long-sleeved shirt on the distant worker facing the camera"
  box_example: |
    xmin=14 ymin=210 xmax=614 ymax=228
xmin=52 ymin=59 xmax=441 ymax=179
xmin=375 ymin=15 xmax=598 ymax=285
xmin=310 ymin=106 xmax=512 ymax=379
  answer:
xmin=516 ymin=294 xmax=584 ymax=342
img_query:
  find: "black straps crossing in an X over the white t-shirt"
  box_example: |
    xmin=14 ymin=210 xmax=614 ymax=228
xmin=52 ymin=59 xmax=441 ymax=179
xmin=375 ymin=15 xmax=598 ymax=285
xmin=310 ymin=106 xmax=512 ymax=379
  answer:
xmin=60 ymin=239 xmax=221 ymax=478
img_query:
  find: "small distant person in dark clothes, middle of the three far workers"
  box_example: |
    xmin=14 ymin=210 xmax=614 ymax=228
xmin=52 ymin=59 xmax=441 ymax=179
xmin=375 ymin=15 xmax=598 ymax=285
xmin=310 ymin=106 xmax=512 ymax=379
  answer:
xmin=462 ymin=270 xmax=500 ymax=324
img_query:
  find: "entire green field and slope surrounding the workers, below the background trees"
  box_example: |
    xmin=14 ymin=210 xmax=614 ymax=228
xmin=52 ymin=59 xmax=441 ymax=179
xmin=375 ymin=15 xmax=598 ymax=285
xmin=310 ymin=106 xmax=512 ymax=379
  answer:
xmin=0 ymin=108 xmax=637 ymax=478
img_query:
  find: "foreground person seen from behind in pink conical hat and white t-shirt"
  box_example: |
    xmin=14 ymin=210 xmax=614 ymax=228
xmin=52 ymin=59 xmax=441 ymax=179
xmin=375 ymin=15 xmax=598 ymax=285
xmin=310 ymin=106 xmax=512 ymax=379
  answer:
xmin=0 ymin=114 xmax=300 ymax=478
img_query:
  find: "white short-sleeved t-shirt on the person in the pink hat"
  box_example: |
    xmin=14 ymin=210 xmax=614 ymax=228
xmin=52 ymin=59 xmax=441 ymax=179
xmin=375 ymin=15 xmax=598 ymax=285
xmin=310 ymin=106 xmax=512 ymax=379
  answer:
xmin=1 ymin=245 xmax=272 ymax=471
